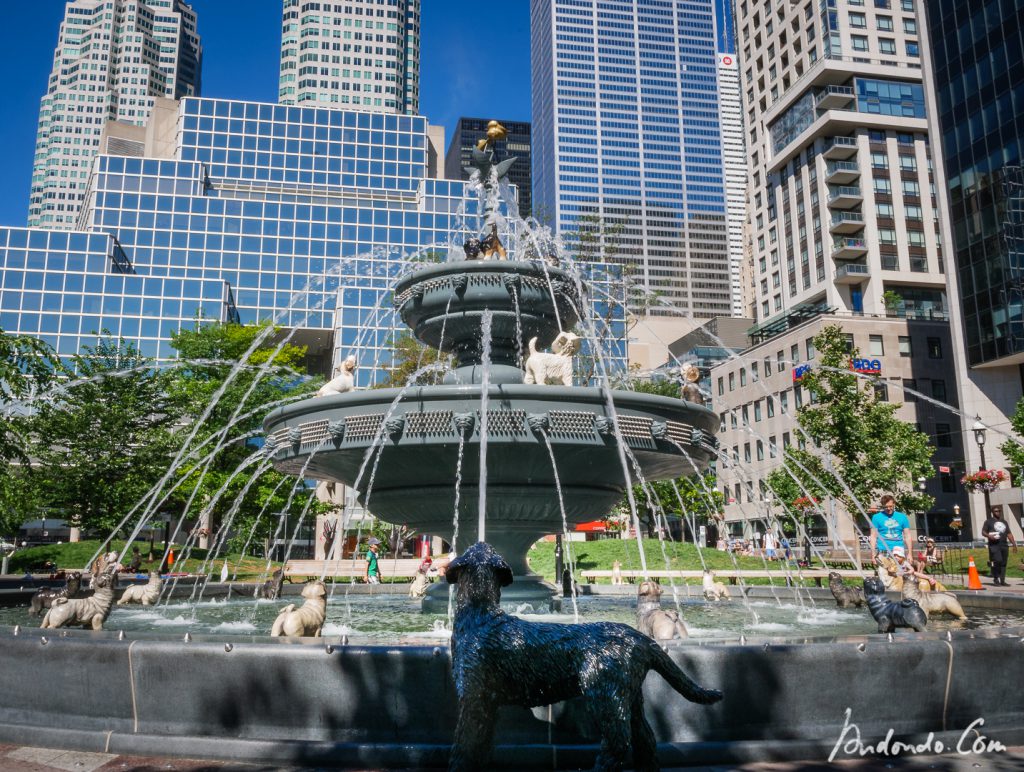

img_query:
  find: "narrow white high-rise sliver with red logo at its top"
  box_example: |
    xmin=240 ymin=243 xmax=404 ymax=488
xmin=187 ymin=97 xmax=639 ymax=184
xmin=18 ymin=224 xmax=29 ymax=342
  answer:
xmin=718 ymin=52 xmax=746 ymax=316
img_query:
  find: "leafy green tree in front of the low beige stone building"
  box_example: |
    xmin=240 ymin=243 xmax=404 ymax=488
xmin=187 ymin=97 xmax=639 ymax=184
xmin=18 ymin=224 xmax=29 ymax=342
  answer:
xmin=767 ymin=326 xmax=934 ymax=514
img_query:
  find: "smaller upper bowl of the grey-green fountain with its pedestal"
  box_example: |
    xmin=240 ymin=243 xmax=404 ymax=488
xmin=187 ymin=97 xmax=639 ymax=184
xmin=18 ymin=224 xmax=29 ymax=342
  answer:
xmin=394 ymin=260 xmax=583 ymax=384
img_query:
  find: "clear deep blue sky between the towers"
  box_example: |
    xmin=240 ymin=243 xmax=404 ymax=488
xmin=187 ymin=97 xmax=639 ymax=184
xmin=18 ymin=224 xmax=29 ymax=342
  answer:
xmin=0 ymin=0 xmax=530 ymax=226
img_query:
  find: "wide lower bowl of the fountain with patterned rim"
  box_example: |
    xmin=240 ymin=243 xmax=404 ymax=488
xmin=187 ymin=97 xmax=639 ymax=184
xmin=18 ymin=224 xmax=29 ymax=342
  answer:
xmin=264 ymin=384 xmax=718 ymax=557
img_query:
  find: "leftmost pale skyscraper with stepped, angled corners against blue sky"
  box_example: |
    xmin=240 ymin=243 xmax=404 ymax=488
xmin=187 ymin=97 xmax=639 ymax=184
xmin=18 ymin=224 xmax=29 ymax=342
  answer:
xmin=29 ymin=0 xmax=202 ymax=229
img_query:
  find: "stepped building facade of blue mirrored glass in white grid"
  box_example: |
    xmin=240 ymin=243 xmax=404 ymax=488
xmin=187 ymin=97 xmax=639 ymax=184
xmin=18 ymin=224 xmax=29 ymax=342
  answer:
xmin=0 ymin=98 xmax=623 ymax=385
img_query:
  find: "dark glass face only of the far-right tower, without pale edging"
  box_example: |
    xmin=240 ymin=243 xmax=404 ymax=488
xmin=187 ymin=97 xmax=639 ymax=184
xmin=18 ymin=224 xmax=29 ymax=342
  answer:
xmin=928 ymin=0 xmax=1024 ymax=367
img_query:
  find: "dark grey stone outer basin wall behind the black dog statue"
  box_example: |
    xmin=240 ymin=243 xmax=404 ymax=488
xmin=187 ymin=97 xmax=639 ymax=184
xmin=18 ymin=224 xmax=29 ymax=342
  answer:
xmin=0 ymin=594 xmax=1024 ymax=769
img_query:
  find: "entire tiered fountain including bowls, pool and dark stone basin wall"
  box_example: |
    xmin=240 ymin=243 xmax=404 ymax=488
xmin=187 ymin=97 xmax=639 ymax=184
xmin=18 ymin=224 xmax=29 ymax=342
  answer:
xmin=0 ymin=123 xmax=1024 ymax=769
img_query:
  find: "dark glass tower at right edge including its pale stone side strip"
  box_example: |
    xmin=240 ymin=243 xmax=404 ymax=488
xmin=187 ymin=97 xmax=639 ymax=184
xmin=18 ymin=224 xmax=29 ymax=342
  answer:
xmin=925 ymin=0 xmax=1024 ymax=539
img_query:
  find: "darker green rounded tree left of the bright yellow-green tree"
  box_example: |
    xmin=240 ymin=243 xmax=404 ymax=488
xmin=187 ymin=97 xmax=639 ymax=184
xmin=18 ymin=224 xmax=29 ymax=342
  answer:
xmin=31 ymin=338 xmax=182 ymax=532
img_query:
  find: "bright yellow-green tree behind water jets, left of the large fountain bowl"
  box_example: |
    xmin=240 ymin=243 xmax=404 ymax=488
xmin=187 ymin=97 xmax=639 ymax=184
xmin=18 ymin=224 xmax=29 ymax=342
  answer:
xmin=168 ymin=323 xmax=327 ymax=547
